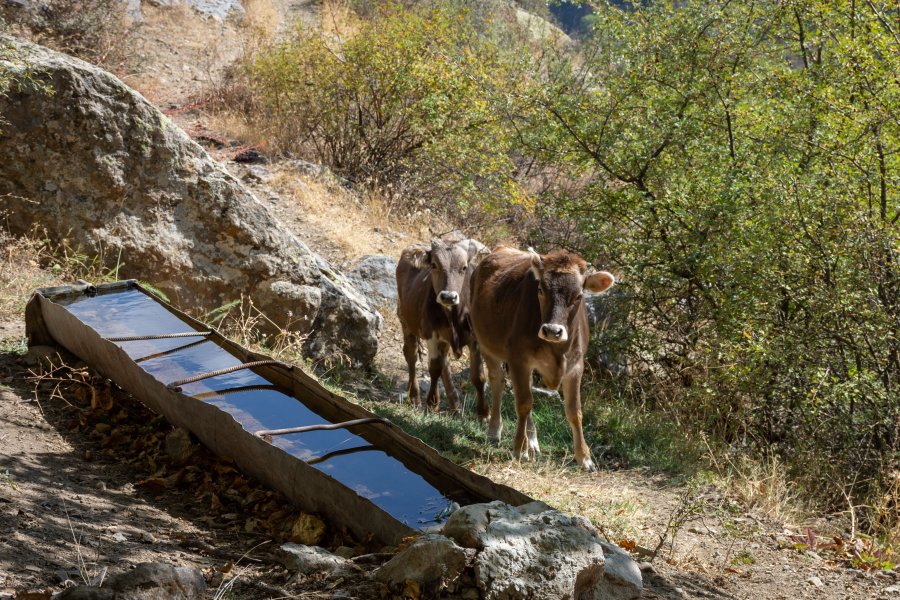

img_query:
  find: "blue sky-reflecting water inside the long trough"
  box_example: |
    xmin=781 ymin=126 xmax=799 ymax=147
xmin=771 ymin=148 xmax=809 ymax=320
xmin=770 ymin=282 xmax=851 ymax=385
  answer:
xmin=57 ymin=288 xmax=467 ymax=529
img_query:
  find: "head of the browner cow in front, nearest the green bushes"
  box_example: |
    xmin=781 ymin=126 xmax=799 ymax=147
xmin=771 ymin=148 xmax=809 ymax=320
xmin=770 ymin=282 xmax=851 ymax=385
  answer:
xmin=529 ymin=248 xmax=616 ymax=344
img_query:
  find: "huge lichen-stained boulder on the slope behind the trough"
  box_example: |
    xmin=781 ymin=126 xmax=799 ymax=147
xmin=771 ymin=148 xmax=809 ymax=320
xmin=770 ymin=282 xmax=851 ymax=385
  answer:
xmin=0 ymin=36 xmax=382 ymax=364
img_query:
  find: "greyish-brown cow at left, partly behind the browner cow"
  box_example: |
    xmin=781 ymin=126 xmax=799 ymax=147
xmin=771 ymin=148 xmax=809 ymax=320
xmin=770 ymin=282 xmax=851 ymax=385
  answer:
xmin=397 ymin=240 xmax=488 ymax=411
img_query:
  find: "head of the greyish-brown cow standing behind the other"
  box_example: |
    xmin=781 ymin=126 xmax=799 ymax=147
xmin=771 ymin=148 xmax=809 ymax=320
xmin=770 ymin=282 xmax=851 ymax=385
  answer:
xmin=413 ymin=240 xmax=488 ymax=309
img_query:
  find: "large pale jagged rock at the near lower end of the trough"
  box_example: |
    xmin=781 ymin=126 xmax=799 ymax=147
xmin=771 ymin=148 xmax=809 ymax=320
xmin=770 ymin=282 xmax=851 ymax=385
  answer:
xmin=443 ymin=501 xmax=643 ymax=600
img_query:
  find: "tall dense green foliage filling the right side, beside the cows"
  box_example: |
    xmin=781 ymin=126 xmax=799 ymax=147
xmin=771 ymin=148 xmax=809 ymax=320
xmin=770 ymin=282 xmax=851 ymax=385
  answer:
xmin=519 ymin=0 xmax=900 ymax=520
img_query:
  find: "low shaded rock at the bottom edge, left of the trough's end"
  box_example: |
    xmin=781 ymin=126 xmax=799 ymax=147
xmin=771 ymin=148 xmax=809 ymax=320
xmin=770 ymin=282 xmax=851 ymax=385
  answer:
xmin=55 ymin=563 xmax=206 ymax=600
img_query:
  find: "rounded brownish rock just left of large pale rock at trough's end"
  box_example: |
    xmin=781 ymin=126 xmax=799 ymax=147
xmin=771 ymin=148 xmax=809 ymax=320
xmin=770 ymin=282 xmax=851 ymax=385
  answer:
xmin=374 ymin=534 xmax=475 ymax=585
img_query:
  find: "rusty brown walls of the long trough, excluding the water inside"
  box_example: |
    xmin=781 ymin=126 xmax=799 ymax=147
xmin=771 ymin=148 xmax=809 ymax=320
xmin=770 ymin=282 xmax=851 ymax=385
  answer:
xmin=26 ymin=280 xmax=532 ymax=545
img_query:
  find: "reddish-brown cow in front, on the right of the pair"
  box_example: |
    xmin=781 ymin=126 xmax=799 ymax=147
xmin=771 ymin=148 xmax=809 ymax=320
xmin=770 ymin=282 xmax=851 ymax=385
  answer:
xmin=469 ymin=246 xmax=615 ymax=471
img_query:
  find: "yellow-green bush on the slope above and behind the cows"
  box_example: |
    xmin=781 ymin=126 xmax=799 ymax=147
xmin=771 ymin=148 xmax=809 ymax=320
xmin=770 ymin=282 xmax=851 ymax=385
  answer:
xmin=247 ymin=4 xmax=518 ymax=207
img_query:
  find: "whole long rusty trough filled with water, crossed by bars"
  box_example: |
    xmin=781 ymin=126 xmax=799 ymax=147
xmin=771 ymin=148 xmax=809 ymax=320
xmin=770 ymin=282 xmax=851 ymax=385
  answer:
xmin=26 ymin=281 xmax=531 ymax=544
